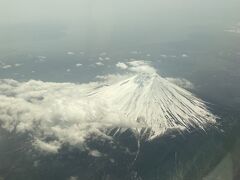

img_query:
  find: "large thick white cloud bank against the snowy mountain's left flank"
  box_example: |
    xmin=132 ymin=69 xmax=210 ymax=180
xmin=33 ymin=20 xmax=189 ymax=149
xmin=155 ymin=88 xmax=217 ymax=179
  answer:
xmin=0 ymin=80 xmax=132 ymax=153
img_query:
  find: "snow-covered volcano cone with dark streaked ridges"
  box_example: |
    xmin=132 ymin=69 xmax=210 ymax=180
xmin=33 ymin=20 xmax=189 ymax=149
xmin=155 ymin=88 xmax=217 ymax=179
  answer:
xmin=90 ymin=72 xmax=216 ymax=136
